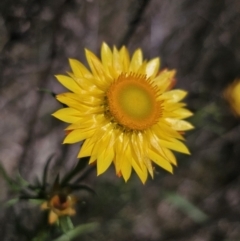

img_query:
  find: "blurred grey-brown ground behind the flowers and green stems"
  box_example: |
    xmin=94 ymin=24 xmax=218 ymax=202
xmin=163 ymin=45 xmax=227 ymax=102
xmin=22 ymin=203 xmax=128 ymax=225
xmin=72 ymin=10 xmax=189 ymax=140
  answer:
xmin=0 ymin=0 xmax=240 ymax=241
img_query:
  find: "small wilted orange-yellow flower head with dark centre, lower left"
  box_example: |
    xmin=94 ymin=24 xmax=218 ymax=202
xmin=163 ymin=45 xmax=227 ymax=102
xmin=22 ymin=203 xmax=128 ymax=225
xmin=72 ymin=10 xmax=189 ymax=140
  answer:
xmin=41 ymin=194 xmax=76 ymax=224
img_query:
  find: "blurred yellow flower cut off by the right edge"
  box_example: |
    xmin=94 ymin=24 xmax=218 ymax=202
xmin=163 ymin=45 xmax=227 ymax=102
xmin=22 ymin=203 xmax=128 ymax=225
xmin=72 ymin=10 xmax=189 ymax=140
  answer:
xmin=223 ymin=79 xmax=240 ymax=116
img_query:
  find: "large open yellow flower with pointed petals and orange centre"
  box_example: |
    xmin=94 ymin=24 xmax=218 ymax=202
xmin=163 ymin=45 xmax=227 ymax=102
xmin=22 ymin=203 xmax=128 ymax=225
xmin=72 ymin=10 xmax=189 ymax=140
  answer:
xmin=53 ymin=43 xmax=193 ymax=183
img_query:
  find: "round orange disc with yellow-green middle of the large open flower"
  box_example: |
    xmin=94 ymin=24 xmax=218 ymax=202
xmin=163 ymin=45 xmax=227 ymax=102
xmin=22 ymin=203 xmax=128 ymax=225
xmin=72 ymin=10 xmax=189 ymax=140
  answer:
xmin=107 ymin=73 xmax=161 ymax=131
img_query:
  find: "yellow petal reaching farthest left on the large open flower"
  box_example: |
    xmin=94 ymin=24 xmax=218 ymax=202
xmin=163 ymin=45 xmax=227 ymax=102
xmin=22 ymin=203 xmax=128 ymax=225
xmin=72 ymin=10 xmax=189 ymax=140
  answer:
xmin=52 ymin=108 xmax=80 ymax=123
